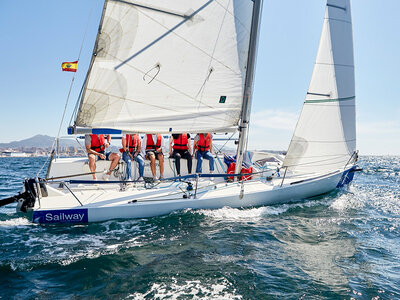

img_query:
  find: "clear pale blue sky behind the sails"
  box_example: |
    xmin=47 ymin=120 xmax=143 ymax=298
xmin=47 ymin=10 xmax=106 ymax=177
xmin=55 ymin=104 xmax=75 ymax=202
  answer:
xmin=0 ymin=0 xmax=400 ymax=155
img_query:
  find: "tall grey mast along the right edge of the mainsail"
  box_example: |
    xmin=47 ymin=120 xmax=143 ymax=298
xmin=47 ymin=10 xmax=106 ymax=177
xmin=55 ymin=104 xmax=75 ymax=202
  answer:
xmin=235 ymin=0 xmax=263 ymax=174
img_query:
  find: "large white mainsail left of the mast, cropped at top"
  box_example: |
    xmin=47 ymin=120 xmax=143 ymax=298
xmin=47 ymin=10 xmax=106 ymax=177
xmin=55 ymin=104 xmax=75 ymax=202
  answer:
xmin=75 ymin=0 xmax=253 ymax=133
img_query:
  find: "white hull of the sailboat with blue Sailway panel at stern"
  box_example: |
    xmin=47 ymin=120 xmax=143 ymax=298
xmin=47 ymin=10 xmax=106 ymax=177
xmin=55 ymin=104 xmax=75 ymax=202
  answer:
xmin=25 ymin=161 xmax=352 ymax=223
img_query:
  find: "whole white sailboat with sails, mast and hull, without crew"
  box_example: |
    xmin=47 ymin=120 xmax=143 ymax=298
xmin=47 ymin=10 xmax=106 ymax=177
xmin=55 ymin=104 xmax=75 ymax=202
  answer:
xmin=1 ymin=0 xmax=357 ymax=224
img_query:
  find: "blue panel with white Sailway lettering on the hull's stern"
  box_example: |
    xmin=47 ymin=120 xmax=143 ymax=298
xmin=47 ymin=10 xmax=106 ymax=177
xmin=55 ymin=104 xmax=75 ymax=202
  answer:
xmin=32 ymin=209 xmax=88 ymax=224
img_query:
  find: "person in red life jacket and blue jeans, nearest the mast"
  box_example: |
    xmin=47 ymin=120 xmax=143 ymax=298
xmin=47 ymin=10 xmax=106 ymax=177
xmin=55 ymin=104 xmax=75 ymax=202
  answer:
xmin=193 ymin=133 xmax=214 ymax=173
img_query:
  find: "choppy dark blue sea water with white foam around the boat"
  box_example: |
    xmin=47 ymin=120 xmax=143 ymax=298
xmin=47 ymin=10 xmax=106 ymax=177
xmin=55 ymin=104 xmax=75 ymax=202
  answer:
xmin=0 ymin=156 xmax=400 ymax=299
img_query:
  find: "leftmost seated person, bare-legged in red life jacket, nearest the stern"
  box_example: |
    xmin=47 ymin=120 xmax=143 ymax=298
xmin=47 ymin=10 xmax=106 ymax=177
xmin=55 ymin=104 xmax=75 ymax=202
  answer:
xmin=85 ymin=134 xmax=120 ymax=180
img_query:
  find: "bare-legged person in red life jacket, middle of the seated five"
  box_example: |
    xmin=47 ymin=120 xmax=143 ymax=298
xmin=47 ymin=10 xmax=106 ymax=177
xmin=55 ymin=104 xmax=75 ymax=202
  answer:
xmin=142 ymin=134 xmax=164 ymax=181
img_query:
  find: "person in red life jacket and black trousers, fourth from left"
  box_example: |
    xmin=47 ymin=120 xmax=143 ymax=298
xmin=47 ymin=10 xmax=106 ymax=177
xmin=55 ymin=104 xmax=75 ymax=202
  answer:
xmin=169 ymin=133 xmax=192 ymax=176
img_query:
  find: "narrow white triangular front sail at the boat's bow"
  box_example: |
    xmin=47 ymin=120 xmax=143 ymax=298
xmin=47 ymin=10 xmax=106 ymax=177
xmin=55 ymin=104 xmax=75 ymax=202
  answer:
xmin=283 ymin=0 xmax=356 ymax=173
